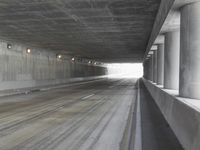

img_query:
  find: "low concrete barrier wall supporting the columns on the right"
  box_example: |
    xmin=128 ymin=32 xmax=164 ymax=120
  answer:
xmin=143 ymin=79 xmax=200 ymax=150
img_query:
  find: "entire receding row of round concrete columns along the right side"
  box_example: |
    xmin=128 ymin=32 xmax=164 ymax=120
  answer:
xmin=144 ymin=2 xmax=200 ymax=99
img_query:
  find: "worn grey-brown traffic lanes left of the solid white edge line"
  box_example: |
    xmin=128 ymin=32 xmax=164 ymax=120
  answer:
xmin=0 ymin=79 xmax=136 ymax=150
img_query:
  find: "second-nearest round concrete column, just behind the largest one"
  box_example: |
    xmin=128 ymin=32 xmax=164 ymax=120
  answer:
xmin=164 ymin=31 xmax=180 ymax=90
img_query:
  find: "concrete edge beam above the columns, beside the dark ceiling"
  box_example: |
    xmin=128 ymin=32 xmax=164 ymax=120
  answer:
xmin=144 ymin=0 xmax=199 ymax=58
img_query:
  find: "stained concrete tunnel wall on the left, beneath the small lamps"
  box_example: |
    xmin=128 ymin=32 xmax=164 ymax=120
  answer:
xmin=0 ymin=41 xmax=106 ymax=90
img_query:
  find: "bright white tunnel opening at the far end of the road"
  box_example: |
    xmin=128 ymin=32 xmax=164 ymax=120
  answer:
xmin=107 ymin=63 xmax=143 ymax=78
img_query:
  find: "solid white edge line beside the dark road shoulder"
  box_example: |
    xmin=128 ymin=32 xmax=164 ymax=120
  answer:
xmin=134 ymin=81 xmax=142 ymax=150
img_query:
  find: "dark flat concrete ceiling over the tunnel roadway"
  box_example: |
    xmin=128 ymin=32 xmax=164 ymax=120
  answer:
xmin=0 ymin=0 xmax=160 ymax=62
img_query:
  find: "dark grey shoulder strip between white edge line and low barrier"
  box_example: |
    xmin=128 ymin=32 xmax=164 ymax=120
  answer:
xmin=140 ymin=82 xmax=183 ymax=150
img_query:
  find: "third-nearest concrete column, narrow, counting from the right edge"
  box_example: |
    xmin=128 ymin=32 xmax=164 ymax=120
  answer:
xmin=157 ymin=44 xmax=164 ymax=85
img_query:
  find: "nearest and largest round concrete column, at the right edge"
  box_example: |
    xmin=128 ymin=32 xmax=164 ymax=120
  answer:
xmin=179 ymin=2 xmax=200 ymax=99
